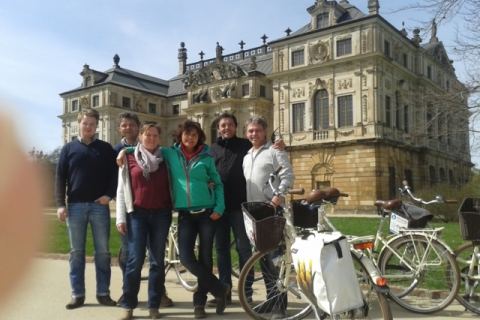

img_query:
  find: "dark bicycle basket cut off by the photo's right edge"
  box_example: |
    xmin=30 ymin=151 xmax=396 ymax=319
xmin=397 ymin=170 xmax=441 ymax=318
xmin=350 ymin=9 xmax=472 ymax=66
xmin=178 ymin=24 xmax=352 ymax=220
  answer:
xmin=458 ymin=198 xmax=480 ymax=240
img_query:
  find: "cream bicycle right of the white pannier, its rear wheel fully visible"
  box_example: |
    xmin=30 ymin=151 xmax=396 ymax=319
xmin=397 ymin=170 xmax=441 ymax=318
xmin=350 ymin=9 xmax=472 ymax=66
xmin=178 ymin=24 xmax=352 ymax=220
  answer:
xmin=354 ymin=182 xmax=460 ymax=313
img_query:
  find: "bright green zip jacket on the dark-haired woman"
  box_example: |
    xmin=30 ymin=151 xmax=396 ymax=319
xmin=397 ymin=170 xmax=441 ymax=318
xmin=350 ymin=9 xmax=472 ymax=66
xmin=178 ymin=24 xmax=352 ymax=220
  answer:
xmin=161 ymin=144 xmax=225 ymax=214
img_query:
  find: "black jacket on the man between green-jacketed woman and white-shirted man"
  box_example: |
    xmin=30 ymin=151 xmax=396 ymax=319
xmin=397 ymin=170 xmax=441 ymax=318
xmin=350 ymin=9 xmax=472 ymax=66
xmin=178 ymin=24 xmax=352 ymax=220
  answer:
xmin=210 ymin=137 xmax=252 ymax=211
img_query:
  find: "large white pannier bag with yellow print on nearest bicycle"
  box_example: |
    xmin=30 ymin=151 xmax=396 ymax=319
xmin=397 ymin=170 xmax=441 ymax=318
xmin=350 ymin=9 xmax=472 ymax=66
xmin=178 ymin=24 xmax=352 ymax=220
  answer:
xmin=292 ymin=232 xmax=364 ymax=315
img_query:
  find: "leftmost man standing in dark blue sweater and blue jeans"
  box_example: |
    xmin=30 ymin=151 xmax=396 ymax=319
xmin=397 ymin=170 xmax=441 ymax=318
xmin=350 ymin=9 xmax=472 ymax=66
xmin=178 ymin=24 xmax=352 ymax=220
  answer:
xmin=55 ymin=109 xmax=117 ymax=309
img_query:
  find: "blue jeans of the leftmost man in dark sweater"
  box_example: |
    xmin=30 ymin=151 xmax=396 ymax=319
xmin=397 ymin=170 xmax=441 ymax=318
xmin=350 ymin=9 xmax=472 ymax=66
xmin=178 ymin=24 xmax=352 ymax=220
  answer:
xmin=67 ymin=202 xmax=111 ymax=297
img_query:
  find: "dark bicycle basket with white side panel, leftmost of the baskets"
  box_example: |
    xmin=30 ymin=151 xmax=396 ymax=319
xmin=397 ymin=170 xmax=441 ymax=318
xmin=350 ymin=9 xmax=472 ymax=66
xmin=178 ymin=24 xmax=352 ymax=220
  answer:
xmin=242 ymin=202 xmax=285 ymax=252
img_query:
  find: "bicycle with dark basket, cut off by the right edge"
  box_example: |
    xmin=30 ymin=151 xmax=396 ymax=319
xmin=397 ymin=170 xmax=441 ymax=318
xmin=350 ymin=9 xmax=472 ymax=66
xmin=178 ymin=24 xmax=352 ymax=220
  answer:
xmin=455 ymin=198 xmax=480 ymax=314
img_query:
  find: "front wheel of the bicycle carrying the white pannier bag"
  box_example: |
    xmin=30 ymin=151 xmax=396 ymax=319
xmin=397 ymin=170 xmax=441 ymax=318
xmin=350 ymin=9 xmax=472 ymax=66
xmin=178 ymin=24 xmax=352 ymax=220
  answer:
xmin=238 ymin=248 xmax=312 ymax=320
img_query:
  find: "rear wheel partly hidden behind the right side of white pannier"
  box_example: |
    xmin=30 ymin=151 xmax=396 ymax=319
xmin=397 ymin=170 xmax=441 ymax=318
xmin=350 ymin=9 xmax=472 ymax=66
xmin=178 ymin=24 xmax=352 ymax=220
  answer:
xmin=348 ymin=253 xmax=393 ymax=320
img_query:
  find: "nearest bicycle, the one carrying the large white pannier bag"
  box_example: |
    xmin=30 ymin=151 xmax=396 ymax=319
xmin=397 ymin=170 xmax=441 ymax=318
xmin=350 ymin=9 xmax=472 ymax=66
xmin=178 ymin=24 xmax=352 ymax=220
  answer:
xmin=238 ymin=171 xmax=392 ymax=320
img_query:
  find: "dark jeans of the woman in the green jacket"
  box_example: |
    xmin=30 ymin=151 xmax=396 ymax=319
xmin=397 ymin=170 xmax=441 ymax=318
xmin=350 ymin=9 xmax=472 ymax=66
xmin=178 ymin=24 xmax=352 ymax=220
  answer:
xmin=178 ymin=210 xmax=224 ymax=306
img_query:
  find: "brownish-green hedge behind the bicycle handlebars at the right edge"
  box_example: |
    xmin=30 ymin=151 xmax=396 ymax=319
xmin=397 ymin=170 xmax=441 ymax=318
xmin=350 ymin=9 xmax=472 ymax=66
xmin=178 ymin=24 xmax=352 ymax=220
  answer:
xmin=407 ymin=173 xmax=480 ymax=221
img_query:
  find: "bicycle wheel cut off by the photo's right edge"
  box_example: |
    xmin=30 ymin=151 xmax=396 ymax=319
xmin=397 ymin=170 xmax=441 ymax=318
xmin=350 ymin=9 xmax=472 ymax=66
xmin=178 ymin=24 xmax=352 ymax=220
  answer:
xmin=455 ymin=242 xmax=480 ymax=314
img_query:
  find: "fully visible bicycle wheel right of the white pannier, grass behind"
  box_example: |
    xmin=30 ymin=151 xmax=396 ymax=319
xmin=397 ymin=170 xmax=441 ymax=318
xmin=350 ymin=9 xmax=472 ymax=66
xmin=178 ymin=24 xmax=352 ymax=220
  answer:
xmin=378 ymin=235 xmax=460 ymax=313
